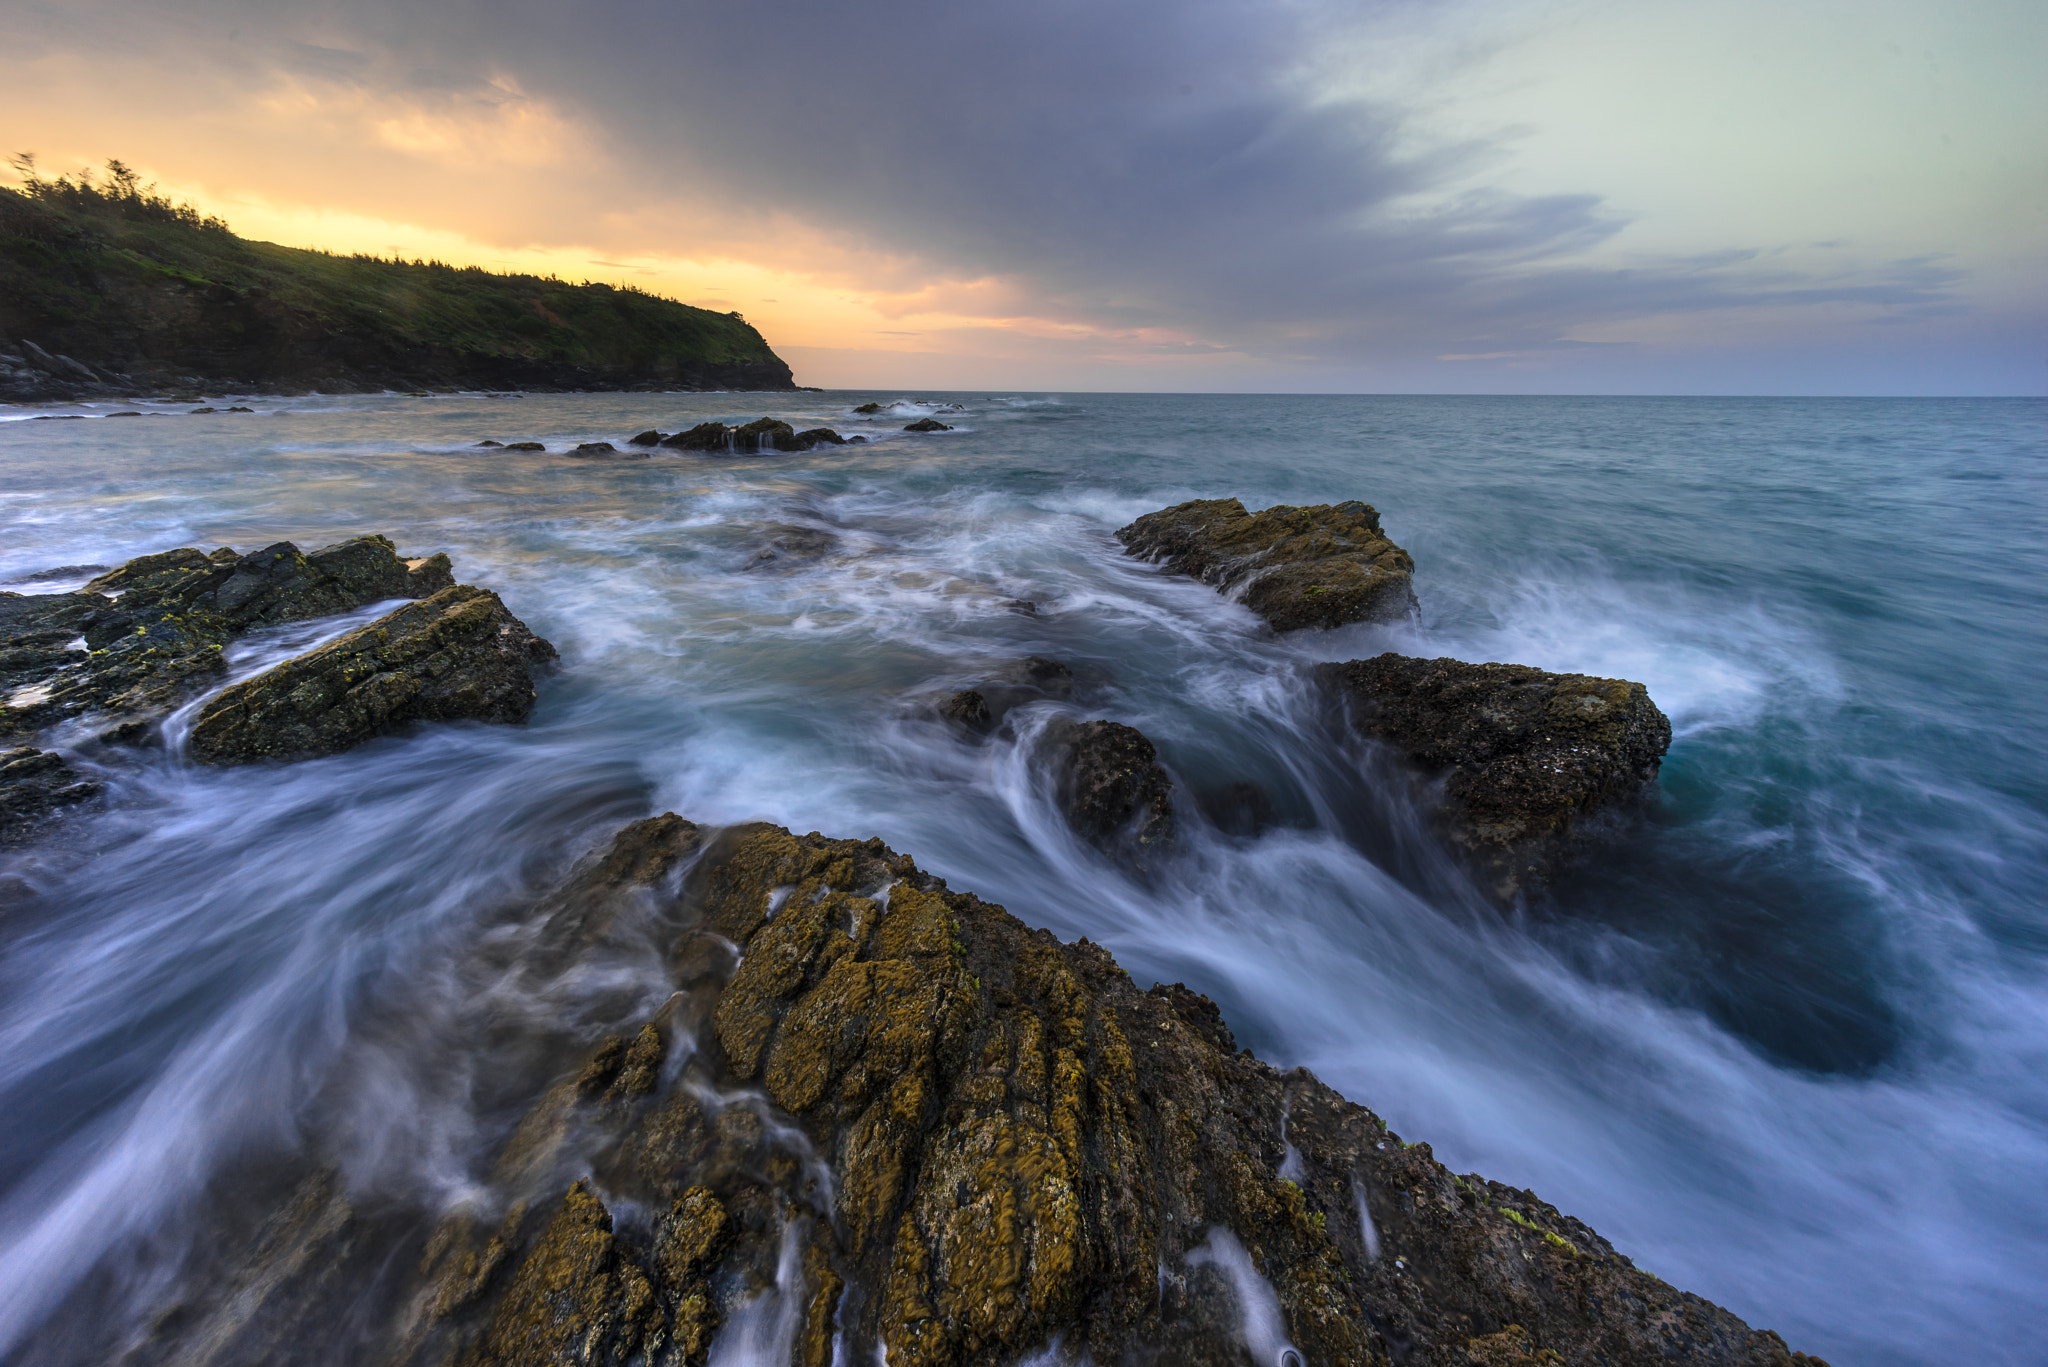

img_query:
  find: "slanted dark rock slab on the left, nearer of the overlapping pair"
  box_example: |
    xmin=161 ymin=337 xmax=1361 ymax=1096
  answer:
xmin=190 ymin=584 xmax=555 ymax=764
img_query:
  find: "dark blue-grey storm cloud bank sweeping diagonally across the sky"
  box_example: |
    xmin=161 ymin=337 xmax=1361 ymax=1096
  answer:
xmin=28 ymin=0 xmax=1954 ymax=357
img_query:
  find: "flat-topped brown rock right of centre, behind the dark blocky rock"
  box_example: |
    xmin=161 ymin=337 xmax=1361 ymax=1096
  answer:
xmin=1116 ymin=498 xmax=1415 ymax=631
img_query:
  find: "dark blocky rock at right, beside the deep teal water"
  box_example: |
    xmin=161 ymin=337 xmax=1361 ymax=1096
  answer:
xmin=1319 ymin=654 xmax=1671 ymax=904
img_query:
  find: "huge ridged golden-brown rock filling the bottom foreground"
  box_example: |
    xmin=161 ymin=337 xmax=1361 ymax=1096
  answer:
xmin=128 ymin=816 xmax=1815 ymax=1367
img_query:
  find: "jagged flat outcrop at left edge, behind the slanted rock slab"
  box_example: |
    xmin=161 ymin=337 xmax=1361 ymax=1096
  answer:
xmin=0 ymin=535 xmax=455 ymax=736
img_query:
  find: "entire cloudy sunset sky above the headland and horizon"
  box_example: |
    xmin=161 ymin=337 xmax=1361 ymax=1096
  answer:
xmin=0 ymin=0 xmax=2048 ymax=393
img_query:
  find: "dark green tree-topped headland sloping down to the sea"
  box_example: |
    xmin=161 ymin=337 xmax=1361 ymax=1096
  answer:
xmin=0 ymin=191 xmax=795 ymax=402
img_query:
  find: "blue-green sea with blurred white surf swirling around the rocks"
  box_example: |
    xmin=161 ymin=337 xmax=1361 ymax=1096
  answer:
xmin=0 ymin=393 xmax=2048 ymax=1365
